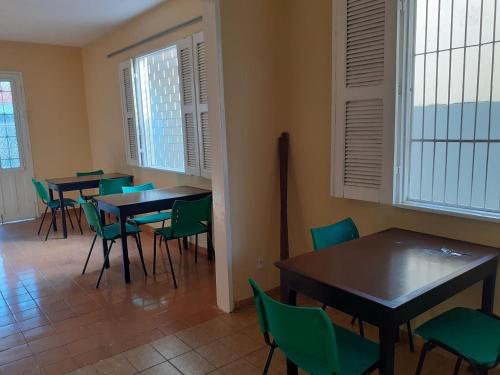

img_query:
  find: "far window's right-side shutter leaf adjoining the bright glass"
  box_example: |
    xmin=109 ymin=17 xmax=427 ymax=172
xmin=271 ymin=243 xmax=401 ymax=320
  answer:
xmin=177 ymin=37 xmax=200 ymax=176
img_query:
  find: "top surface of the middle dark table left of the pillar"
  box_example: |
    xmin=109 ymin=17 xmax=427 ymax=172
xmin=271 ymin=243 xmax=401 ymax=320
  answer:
xmin=94 ymin=186 xmax=212 ymax=216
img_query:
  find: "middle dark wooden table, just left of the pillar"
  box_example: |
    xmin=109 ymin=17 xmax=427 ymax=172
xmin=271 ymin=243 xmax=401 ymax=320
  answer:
xmin=95 ymin=186 xmax=213 ymax=283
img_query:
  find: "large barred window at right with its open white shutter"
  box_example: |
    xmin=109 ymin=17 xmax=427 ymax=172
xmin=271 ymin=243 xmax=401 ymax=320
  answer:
xmin=332 ymin=0 xmax=500 ymax=220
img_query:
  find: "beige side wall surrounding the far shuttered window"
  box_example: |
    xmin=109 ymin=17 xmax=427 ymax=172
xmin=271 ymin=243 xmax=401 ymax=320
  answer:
xmin=83 ymin=0 xmax=210 ymax=192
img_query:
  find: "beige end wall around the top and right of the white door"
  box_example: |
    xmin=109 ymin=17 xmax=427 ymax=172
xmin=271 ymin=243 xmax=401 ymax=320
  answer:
xmin=0 ymin=41 xmax=91 ymax=187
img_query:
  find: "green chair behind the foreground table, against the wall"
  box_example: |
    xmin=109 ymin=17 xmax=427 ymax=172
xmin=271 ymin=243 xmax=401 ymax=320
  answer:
xmin=311 ymin=217 xmax=415 ymax=352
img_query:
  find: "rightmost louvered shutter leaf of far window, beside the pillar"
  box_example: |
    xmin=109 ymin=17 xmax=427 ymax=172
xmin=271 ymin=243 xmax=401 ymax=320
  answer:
xmin=193 ymin=32 xmax=212 ymax=178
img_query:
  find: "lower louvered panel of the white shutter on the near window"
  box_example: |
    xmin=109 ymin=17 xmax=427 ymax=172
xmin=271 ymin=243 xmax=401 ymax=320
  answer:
xmin=344 ymin=99 xmax=383 ymax=188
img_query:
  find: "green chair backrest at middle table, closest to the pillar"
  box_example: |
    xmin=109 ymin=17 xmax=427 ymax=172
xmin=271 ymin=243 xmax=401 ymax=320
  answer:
xmin=172 ymin=195 xmax=212 ymax=234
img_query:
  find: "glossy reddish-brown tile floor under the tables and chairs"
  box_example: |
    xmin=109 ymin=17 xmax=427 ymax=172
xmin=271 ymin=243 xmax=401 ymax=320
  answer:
xmin=0 ymin=222 xmax=498 ymax=375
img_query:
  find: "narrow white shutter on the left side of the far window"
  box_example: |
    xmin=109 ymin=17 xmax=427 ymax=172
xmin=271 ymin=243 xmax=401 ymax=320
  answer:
xmin=119 ymin=60 xmax=139 ymax=166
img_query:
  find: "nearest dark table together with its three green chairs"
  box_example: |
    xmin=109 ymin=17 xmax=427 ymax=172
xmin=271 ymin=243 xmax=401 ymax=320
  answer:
xmin=249 ymin=218 xmax=500 ymax=375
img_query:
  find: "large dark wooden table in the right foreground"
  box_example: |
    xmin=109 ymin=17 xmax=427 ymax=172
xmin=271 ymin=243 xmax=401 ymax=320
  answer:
xmin=276 ymin=229 xmax=500 ymax=375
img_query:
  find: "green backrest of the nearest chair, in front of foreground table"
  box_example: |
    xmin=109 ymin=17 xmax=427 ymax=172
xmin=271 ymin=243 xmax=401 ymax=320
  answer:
xmin=249 ymin=279 xmax=340 ymax=375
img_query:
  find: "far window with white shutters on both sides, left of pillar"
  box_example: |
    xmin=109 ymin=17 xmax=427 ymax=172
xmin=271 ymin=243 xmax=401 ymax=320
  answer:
xmin=120 ymin=33 xmax=211 ymax=178
